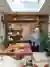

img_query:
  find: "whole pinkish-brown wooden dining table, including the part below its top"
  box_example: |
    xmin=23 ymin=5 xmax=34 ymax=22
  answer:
xmin=0 ymin=45 xmax=32 ymax=59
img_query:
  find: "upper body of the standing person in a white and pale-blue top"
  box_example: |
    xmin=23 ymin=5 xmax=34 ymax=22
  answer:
xmin=26 ymin=28 xmax=40 ymax=46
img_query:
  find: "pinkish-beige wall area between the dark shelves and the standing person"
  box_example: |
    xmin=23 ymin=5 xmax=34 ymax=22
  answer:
xmin=22 ymin=23 xmax=31 ymax=39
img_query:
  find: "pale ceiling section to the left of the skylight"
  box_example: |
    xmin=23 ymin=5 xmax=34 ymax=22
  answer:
xmin=0 ymin=0 xmax=11 ymax=12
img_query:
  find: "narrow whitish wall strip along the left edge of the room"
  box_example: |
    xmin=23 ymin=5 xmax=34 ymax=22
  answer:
xmin=0 ymin=12 xmax=5 ymax=50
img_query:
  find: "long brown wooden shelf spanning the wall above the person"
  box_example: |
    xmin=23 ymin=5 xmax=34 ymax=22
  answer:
xmin=4 ymin=12 xmax=48 ymax=23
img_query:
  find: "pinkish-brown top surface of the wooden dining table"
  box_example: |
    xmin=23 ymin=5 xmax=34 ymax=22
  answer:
xmin=0 ymin=45 xmax=32 ymax=56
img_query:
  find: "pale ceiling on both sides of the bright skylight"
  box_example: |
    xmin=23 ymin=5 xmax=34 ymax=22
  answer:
xmin=0 ymin=0 xmax=50 ymax=15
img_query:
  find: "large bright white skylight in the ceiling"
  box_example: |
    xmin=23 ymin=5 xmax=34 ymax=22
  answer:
xmin=6 ymin=0 xmax=45 ymax=12
